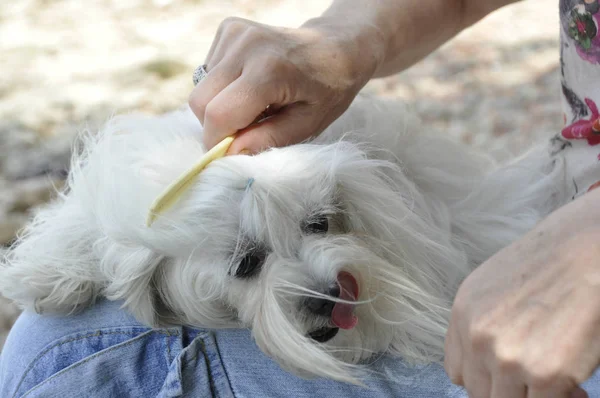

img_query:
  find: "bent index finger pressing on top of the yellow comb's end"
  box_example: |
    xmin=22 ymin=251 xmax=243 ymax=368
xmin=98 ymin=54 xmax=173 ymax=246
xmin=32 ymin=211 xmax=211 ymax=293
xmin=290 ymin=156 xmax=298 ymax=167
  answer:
xmin=204 ymin=76 xmax=281 ymax=148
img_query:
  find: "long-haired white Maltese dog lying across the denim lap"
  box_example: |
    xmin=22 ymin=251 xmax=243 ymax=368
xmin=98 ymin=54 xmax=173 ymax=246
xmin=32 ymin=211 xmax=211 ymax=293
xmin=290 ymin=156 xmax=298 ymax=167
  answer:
xmin=0 ymin=98 xmax=568 ymax=382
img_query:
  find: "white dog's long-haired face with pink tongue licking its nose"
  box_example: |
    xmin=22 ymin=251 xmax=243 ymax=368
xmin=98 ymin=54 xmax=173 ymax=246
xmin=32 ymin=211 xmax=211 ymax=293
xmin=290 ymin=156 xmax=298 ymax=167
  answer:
xmin=131 ymin=138 xmax=458 ymax=380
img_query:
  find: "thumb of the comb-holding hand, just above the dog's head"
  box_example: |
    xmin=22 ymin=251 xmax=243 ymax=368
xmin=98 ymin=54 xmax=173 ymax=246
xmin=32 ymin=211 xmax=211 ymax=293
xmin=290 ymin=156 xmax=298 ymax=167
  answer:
xmin=229 ymin=104 xmax=320 ymax=154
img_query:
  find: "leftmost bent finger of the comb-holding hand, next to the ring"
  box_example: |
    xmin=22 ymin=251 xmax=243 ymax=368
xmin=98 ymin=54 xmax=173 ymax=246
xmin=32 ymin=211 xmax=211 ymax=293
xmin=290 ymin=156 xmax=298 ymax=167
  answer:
xmin=188 ymin=64 xmax=242 ymax=125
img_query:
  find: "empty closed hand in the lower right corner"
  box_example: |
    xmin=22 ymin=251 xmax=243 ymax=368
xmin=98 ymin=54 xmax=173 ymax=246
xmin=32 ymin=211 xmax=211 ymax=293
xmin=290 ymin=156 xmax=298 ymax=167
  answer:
xmin=445 ymin=190 xmax=600 ymax=398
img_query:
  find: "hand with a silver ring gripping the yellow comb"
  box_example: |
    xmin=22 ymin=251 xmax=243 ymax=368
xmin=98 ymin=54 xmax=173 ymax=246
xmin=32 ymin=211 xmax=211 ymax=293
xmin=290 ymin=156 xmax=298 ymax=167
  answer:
xmin=189 ymin=18 xmax=382 ymax=154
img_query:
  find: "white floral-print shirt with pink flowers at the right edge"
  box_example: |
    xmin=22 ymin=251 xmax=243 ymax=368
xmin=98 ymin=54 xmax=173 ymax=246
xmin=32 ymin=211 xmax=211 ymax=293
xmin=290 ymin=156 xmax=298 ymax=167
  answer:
xmin=552 ymin=0 xmax=600 ymax=198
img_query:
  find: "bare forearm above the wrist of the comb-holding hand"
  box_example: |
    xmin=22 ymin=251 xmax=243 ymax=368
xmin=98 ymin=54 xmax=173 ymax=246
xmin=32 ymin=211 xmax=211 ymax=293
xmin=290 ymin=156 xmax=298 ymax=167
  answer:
xmin=307 ymin=0 xmax=517 ymax=77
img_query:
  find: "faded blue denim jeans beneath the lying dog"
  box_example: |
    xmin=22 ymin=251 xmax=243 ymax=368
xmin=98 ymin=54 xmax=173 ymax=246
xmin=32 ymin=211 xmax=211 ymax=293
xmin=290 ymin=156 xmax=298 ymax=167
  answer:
xmin=0 ymin=301 xmax=600 ymax=398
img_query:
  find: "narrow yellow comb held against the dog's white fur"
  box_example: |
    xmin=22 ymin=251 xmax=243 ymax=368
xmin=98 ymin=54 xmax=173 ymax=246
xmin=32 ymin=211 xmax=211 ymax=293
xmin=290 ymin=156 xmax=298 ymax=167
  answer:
xmin=146 ymin=136 xmax=233 ymax=227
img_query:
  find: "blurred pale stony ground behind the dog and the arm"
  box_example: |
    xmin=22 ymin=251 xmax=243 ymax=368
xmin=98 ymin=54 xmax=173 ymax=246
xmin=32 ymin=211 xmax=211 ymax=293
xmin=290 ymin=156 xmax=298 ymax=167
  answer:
xmin=0 ymin=0 xmax=562 ymax=347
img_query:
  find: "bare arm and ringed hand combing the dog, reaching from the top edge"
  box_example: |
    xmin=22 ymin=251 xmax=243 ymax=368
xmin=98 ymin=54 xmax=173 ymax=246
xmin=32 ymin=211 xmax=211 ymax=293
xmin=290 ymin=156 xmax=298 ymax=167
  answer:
xmin=190 ymin=0 xmax=512 ymax=153
